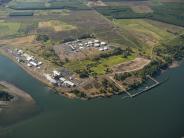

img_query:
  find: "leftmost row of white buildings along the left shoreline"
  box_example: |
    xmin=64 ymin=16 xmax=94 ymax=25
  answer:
xmin=15 ymin=49 xmax=43 ymax=68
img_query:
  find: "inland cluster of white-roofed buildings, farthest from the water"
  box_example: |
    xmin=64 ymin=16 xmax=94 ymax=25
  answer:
xmin=64 ymin=39 xmax=109 ymax=52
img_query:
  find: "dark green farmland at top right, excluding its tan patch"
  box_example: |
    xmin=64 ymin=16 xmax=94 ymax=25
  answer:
xmin=96 ymin=1 xmax=184 ymax=26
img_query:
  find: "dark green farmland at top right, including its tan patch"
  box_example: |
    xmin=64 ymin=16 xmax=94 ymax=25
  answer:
xmin=96 ymin=0 xmax=184 ymax=26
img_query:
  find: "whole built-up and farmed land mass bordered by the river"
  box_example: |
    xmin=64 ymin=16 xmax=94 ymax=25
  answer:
xmin=0 ymin=0 xmax=184 ymax=99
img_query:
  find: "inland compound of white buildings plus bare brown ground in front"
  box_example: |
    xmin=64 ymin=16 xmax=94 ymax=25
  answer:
xmin=54 ymin=38 xmax=110 ymax=61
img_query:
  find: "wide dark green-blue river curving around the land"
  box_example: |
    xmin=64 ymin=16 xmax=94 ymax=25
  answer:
xmin=0 ymin=56 xmax=184 ymax=138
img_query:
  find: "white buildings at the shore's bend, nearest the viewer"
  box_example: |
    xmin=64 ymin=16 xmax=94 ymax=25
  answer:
xmin=44 ymin=70 xmax=75 ymax=87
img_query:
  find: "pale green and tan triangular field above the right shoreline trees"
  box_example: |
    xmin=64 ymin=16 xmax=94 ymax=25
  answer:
xmin=114 ymin=19 xmax=184 ymax=55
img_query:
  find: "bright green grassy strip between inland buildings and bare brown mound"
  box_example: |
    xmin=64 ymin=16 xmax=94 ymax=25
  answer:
xmin=65 ymin=55 xmax=135 ymax=75
